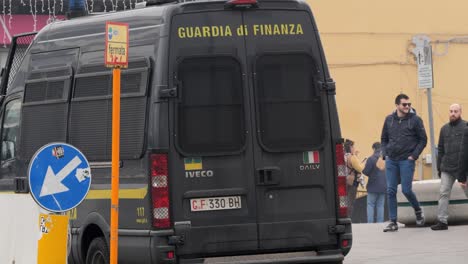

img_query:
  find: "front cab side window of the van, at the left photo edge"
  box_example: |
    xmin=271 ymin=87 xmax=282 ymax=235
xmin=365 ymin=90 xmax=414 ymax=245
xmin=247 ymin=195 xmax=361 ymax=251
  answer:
xmin=1 ymin=99 xmax=21 ymax=161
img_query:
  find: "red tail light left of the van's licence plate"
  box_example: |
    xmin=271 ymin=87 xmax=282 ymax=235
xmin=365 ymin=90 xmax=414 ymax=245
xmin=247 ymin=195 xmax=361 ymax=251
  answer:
xmin=151 ymin=154 xmax=171 ymax=228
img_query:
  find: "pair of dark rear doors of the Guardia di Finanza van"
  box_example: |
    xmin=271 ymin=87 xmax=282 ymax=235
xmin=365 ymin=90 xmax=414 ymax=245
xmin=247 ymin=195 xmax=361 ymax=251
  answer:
xmin=169 ymin=2 xmax=337 ymax=257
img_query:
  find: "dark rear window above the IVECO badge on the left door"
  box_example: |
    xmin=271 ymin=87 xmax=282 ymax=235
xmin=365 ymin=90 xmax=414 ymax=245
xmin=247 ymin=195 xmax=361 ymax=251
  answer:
xmin=177 ymin=57 xmax=245 ymax=154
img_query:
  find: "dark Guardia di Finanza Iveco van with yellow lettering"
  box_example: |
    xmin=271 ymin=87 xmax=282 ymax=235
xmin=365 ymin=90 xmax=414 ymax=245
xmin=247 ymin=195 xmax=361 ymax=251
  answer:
xmin=0 ymin=0 xmax=352 ymax=264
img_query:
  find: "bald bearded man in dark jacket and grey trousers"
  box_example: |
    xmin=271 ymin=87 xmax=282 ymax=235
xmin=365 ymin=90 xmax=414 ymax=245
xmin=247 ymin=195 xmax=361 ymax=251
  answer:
xmin=431 ymin=104 xmax=466 ymax=230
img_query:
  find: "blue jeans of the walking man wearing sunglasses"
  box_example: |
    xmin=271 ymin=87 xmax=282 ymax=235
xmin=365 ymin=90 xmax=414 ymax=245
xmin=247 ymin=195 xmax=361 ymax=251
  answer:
xmin=385 ymin=157 xmax=421 ymax=221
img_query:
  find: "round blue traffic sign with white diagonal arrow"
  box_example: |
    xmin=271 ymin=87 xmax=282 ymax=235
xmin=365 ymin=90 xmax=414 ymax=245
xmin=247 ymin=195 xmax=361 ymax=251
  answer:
xmin=28 ymin=143 xmax=91 ymax=212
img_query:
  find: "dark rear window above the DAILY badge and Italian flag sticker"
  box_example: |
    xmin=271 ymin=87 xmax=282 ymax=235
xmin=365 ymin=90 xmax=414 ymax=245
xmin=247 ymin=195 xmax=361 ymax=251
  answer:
xmin=255 ymin=54 xmax=324 ymax=151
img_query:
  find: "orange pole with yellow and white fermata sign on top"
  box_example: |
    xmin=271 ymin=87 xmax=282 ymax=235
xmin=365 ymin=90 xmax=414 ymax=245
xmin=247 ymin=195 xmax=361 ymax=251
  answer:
xmin=104 ymin=22 xmax=128 ymax=264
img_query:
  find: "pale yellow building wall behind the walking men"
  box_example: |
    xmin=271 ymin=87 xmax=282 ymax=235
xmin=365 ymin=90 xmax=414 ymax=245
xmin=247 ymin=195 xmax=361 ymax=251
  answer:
xmin=308 ymin=0 xmax=468 ymax=179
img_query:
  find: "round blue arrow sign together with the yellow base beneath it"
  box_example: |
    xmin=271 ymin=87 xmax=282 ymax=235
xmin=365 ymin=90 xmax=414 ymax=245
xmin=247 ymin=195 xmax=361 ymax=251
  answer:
xmin=28 ymin=143 xmax=91 ymax=264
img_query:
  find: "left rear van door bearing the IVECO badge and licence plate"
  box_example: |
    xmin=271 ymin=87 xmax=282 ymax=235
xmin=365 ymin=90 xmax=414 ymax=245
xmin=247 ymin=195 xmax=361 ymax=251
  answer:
xmin=169 ymin=10 xmax=258 ymax=256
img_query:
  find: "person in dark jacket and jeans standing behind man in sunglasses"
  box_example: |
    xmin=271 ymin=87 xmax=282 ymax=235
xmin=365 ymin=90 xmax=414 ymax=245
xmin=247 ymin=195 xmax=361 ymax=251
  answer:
xmin=362 ymin=142 xmax=387 ymax=223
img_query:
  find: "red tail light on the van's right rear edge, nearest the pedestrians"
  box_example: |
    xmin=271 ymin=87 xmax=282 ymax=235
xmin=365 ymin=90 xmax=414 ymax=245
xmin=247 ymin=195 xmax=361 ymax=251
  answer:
xmin=335 ymin=143 xmax=348 ymax=218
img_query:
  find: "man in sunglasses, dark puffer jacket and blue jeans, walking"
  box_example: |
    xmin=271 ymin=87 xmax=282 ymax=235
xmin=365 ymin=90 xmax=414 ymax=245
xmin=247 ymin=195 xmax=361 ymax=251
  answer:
xmin=381 ymin=94 xmax=427 ymax=232
